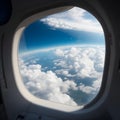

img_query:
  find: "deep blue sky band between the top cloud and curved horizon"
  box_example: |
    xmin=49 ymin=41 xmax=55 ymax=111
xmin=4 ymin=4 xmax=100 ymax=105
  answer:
xmin=19 ymin=7 xmax=105 ymax=52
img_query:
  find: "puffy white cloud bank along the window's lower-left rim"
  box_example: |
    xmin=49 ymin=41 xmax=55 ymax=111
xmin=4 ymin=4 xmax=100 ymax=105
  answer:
xmin=19 ymin=60 xmax=77 ymax=106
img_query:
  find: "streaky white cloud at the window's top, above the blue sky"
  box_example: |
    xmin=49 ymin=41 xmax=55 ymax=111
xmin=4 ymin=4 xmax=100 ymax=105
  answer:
xmin=41 ymin=7 xmax=103 ymax=33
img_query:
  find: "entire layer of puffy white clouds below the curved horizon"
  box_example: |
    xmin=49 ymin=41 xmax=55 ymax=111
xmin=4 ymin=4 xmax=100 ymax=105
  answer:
xmin=19 ymin=47 xmax=105 ymax=106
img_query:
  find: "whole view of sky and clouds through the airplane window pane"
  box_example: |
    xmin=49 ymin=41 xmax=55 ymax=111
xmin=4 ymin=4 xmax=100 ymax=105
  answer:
xmin=18 ymin=7 xmax=105 ymax=106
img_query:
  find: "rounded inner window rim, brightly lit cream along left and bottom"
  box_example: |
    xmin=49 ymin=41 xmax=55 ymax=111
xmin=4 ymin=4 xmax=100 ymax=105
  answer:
xmin=12 ymin=6 xmax=107 ymax=112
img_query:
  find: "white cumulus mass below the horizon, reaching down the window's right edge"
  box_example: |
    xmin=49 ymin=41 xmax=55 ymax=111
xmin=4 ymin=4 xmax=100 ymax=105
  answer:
xmin=54 ymin=47 xmax=105 ymax=94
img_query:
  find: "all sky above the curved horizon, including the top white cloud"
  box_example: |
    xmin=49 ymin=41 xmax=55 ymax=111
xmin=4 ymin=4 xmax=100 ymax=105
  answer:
xmin=19 ymin=7 xmax=105 ymax=52
